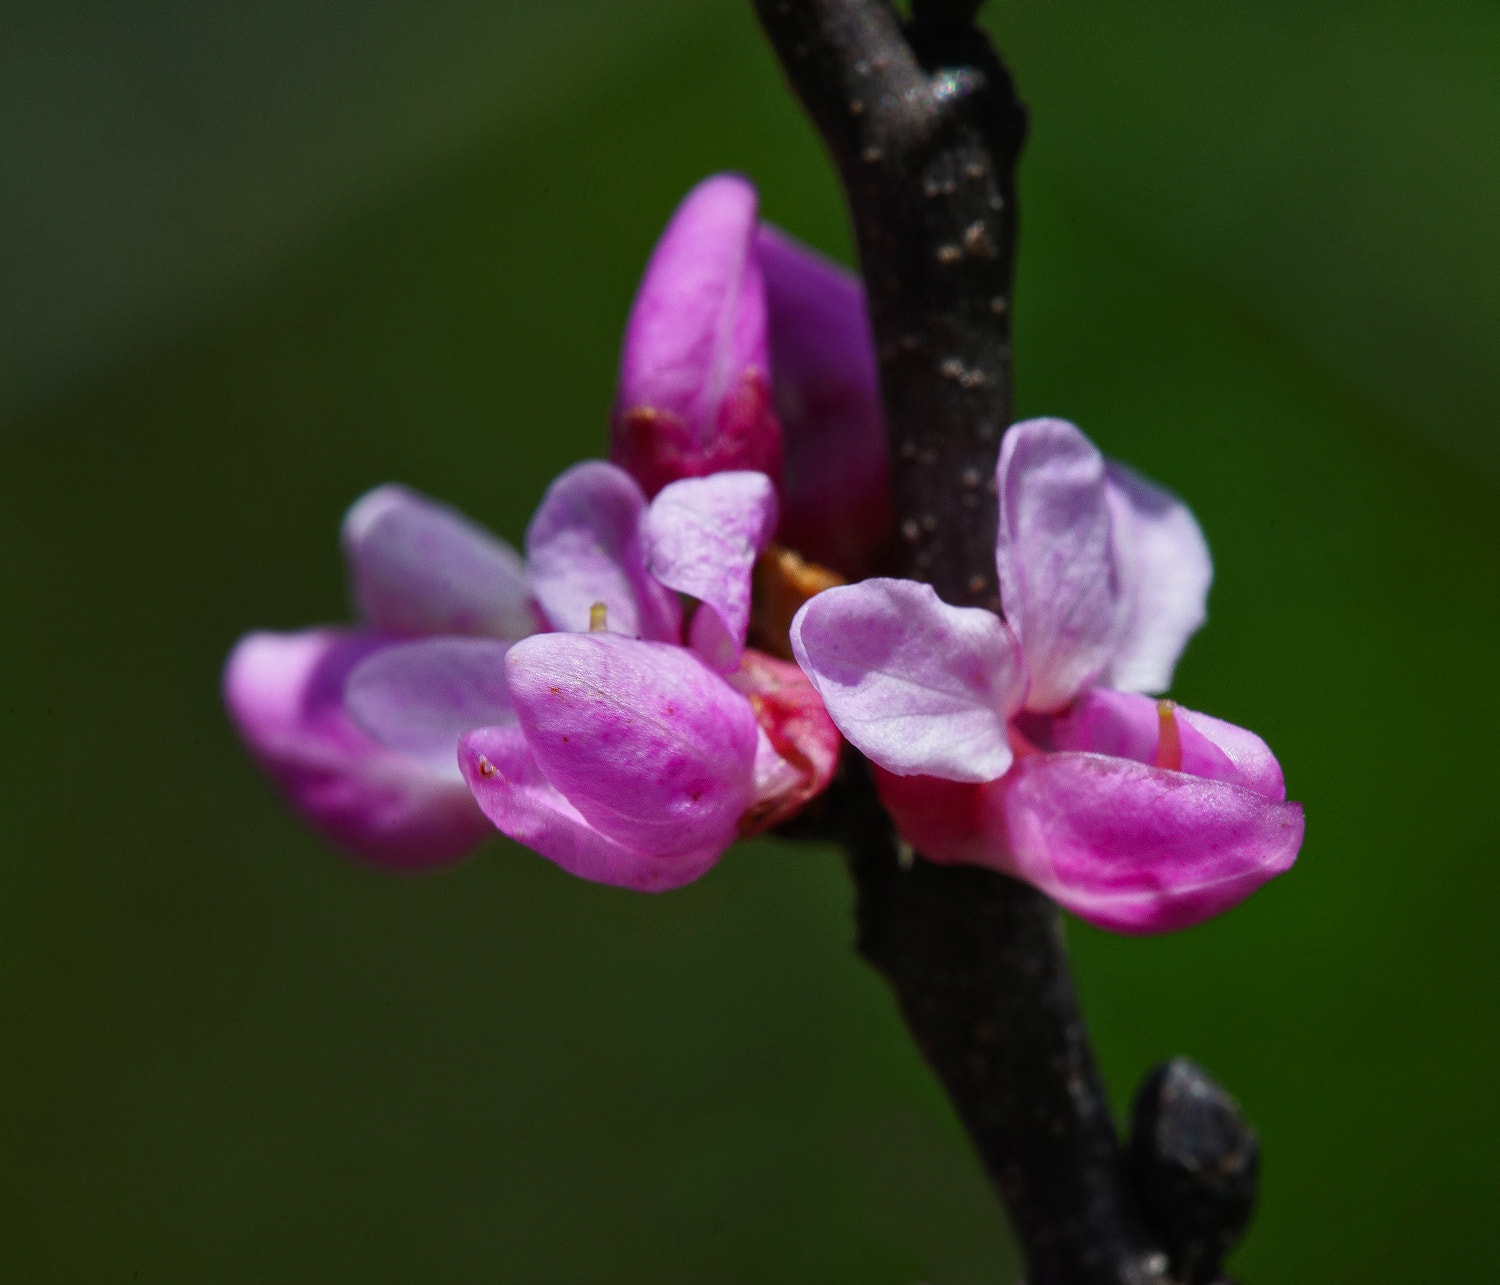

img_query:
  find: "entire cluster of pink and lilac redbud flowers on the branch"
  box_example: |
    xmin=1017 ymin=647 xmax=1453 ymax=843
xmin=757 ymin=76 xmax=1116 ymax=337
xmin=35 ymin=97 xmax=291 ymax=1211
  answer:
xmin=225 ymin=175 xmax=1302 ymax=931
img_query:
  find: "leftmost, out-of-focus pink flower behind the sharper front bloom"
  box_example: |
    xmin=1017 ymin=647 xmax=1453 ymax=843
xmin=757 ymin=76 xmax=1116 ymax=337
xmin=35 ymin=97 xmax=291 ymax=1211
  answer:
xmin=224 ymin=486 xmax=540 ymax=868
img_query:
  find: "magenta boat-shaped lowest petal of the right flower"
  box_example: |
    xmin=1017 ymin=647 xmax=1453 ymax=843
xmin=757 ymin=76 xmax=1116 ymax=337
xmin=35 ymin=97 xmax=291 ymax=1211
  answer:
xmin=986 ymin=753 xmax=1302 ymax=933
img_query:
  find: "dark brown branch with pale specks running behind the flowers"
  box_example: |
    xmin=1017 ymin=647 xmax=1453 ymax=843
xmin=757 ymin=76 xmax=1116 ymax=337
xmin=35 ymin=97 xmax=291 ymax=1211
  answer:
xmin=755 ymin=0 xmax=1260 ymax=1285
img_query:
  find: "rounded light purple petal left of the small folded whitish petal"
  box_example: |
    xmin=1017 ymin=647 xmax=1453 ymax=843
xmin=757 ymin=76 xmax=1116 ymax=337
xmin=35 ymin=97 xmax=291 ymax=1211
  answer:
xmin=527 ymin=460 xmax=681 ymax=642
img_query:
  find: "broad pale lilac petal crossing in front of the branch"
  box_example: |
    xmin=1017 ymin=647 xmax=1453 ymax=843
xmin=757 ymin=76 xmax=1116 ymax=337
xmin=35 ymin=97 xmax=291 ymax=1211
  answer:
xmin=792 ymin=580 xmax=1025 ymax=781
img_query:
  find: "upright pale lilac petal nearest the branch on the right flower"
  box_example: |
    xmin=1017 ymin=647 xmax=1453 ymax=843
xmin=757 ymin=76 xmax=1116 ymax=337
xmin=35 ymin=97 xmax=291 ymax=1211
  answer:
xmin=995 ymin=420 xmax=1124 ymax=712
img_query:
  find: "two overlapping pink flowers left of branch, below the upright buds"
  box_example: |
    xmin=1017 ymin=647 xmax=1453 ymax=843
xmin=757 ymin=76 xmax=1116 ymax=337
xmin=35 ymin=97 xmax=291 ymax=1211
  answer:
xmin=225 ymin=462 xmax=839 ymax=889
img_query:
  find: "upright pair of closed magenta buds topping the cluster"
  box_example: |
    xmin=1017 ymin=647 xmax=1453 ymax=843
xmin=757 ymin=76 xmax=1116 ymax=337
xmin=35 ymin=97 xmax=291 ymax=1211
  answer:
xmin=611 ymin=174 xmax=891 ymax=576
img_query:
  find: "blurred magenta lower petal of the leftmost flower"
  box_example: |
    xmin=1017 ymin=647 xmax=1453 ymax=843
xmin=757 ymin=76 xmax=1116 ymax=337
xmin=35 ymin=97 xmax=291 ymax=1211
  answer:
xmin=224 ymin=630 xmax=489 ymax=868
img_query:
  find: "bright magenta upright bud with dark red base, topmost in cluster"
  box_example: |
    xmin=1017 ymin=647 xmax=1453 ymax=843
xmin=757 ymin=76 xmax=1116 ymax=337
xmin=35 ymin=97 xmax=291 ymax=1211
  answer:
xmin=611 ymin=174 xmax=782 ymax=495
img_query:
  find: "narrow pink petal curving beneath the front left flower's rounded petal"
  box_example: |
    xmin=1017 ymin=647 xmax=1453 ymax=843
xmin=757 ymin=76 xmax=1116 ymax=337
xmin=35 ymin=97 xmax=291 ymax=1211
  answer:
xmin=459 ymin=726 xmax=719 ymax=892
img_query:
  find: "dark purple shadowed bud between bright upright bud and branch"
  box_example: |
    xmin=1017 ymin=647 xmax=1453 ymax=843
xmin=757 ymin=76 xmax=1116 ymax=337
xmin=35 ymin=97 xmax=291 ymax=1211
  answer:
xmin=755 ymin=223 xmax=893 ymax=579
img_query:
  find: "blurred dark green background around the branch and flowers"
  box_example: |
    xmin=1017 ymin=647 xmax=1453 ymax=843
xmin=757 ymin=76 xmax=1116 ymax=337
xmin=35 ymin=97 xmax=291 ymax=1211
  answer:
xmin=0 ymin=0 xmax=1500 ymax=1285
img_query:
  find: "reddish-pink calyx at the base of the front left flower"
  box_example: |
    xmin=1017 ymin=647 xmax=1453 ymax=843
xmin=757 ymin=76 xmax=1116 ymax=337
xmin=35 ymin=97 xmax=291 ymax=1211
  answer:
xmin=729 ymin=649 xmax=843 ymax=837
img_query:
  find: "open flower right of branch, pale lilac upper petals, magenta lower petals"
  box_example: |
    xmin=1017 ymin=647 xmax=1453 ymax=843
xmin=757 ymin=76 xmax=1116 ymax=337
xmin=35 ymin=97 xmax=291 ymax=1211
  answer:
xmin=792 ymin=420 xmax=1302 ymax=933
